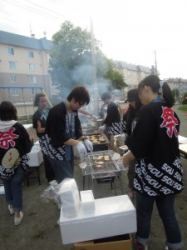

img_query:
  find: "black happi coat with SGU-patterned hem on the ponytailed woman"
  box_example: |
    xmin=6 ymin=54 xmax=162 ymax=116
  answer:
xmin=126 ymin=101 xmax=183 ymax=196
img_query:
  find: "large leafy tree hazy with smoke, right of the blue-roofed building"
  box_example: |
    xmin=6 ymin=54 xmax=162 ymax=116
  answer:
xmin=50 ymin=21 xmax=107 ymax=94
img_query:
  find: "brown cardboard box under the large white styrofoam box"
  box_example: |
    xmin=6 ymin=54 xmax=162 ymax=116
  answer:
xmin=74 ymin=235 xmax=132 ymax=250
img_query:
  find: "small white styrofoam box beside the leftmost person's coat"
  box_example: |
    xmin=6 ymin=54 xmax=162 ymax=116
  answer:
xmin=28 ymin=145 xmax=43 ymax=167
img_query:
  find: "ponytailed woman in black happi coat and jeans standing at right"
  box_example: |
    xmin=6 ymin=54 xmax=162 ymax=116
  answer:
xmin=123 ymin=75 xmax=183 ymax=250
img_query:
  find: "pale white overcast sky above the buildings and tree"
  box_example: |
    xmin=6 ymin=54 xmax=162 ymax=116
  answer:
xmin=0 ymin=0 xmax=187 ymax=79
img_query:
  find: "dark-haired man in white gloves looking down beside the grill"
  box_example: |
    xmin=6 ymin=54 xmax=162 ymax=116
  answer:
xmin=42 ymin=87 xmax=93 ymax=183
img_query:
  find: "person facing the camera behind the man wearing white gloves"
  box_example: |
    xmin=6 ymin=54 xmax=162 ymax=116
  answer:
xmin=32 ymin=93 xmax=55 ymax=182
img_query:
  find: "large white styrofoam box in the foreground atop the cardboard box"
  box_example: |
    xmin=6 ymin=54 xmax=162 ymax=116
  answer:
xmin=59 ymin=195 xmax=136 ymax=244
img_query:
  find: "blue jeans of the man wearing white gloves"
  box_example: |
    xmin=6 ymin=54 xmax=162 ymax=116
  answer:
xmin=49 ymin=159 xmax=74 ymax=183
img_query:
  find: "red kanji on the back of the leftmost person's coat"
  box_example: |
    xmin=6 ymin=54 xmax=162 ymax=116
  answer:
xmin=0 ymin=128 xmax=19 ymax=149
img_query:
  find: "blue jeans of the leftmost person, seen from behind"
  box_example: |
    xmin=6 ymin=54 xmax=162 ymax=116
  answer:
xmin=3 ymin=167 xmax=24 ymax=212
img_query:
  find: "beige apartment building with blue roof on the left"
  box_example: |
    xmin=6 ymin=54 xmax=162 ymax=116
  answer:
xmin=0 ymin=31 xmax=52 ymax=116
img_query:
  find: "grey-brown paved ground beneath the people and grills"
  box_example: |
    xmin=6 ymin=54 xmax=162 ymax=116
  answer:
xmin=0 ymin=106 xmax=187 ymax=250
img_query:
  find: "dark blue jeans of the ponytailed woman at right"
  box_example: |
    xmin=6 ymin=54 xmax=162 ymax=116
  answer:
xmin=136 ymin=193 xmax=182 ymax=249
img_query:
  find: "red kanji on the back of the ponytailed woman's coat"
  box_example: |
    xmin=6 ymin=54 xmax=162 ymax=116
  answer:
xmin=160 ymin=107 xmax=179 ymax=138
